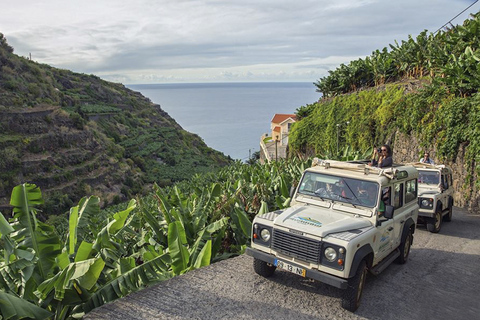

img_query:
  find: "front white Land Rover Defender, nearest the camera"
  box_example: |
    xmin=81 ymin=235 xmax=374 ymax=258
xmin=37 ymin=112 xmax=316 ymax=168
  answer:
xmin=246 ymin=159 xmax=418 ymax=312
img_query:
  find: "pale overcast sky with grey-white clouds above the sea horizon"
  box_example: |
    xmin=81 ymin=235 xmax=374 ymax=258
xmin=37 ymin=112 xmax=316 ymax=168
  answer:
xmin=0 ymin=0 xmax=480 ymax=84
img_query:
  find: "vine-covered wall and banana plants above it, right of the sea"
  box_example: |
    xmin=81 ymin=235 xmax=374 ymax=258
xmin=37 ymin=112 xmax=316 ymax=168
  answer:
xmin=289 ymin=13 xmax=480 ymax=192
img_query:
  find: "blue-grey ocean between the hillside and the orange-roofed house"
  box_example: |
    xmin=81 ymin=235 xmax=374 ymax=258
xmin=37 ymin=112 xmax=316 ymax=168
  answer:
xmin=127 ymin=82 xmax=320 ymax=161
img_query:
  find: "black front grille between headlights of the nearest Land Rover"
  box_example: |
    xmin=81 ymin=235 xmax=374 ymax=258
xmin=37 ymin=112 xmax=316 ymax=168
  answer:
xmin=272 ymin=229 xmax=322 ymax=264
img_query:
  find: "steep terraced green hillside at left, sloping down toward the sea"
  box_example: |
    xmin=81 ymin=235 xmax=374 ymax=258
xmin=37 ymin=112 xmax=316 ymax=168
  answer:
xmin=0 ymin=34 xmax=231 ymax=212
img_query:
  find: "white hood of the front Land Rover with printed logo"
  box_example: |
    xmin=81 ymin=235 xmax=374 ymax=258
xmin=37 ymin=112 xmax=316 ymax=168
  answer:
xmin=274 ymin=205 xmax=372 ymax=237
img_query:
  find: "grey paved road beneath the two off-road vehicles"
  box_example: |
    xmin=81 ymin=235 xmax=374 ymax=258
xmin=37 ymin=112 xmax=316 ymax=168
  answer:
xmin=85 ymin=208 xmax=480 ymax=320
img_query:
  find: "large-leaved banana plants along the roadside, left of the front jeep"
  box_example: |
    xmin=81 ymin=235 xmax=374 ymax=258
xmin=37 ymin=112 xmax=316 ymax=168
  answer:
xmin=0 ymin=159 xmax=311 ymax=319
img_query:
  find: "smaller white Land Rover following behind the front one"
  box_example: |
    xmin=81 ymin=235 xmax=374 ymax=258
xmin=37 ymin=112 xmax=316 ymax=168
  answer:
xmin=412 ymin=162 xmax=453 ymax=233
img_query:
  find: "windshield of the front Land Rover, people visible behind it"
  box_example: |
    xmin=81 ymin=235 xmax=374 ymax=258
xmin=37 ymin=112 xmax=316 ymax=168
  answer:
xmin=298 ymin=172 xmax=378 ymax=208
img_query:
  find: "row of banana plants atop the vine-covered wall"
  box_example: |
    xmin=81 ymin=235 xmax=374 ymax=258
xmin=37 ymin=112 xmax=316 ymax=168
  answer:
xmin=315 ymin=12 xmax=480 ymax=98
